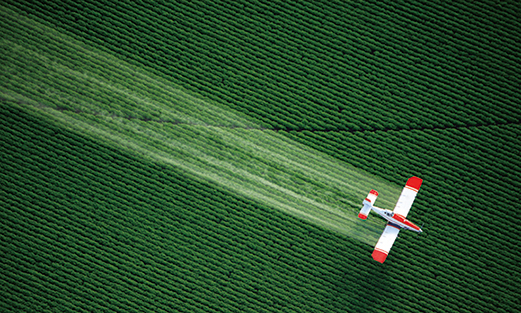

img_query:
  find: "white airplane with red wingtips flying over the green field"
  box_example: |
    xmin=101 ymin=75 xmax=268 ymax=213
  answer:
xmin=358 ymin=176 xmax=423 ymax=263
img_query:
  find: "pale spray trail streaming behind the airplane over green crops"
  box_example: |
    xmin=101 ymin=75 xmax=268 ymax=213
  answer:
xmin=0 ymin=5 xmax=400 ymax=244
